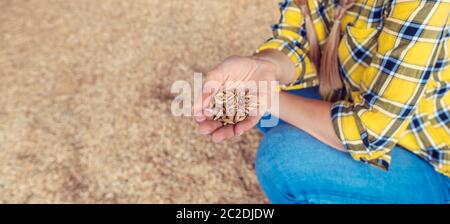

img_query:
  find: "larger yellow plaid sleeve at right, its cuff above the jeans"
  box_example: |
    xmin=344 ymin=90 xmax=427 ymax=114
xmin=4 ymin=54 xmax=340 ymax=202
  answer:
xmin=332 ymin=1 xmax=450 ymax=169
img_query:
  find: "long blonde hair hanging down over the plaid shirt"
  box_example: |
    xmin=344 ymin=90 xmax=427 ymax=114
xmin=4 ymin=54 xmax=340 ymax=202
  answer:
xmin=295 ymin=0 xmax=354 ymax=101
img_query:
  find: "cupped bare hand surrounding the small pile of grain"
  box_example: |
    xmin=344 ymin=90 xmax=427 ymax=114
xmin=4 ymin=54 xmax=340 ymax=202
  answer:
xmin=193 ymin=56 xmax=278 ymax=143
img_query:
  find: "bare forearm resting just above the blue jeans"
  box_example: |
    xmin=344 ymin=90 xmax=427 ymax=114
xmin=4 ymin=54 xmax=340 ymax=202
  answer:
xmin=278 ymin=92 xmax=346 ymax=151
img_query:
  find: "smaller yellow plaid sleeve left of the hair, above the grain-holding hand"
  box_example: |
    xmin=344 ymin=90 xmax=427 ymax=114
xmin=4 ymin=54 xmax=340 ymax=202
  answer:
xmin=257 ymin=0 xmax=317 ymax=90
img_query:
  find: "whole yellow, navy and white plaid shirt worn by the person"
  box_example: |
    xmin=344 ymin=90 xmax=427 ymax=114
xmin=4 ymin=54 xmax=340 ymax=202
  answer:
xmin=259 ymin=0 xmax=450 ymax=176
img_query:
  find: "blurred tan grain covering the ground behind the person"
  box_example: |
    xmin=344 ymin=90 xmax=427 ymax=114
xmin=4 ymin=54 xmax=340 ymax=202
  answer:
xmin=0 ymin=0 xmax=278 ymax=203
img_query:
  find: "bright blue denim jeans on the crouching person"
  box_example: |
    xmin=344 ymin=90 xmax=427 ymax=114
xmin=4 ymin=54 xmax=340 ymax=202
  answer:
xmin=256 ymin=88 xmax=450 ymax=204
